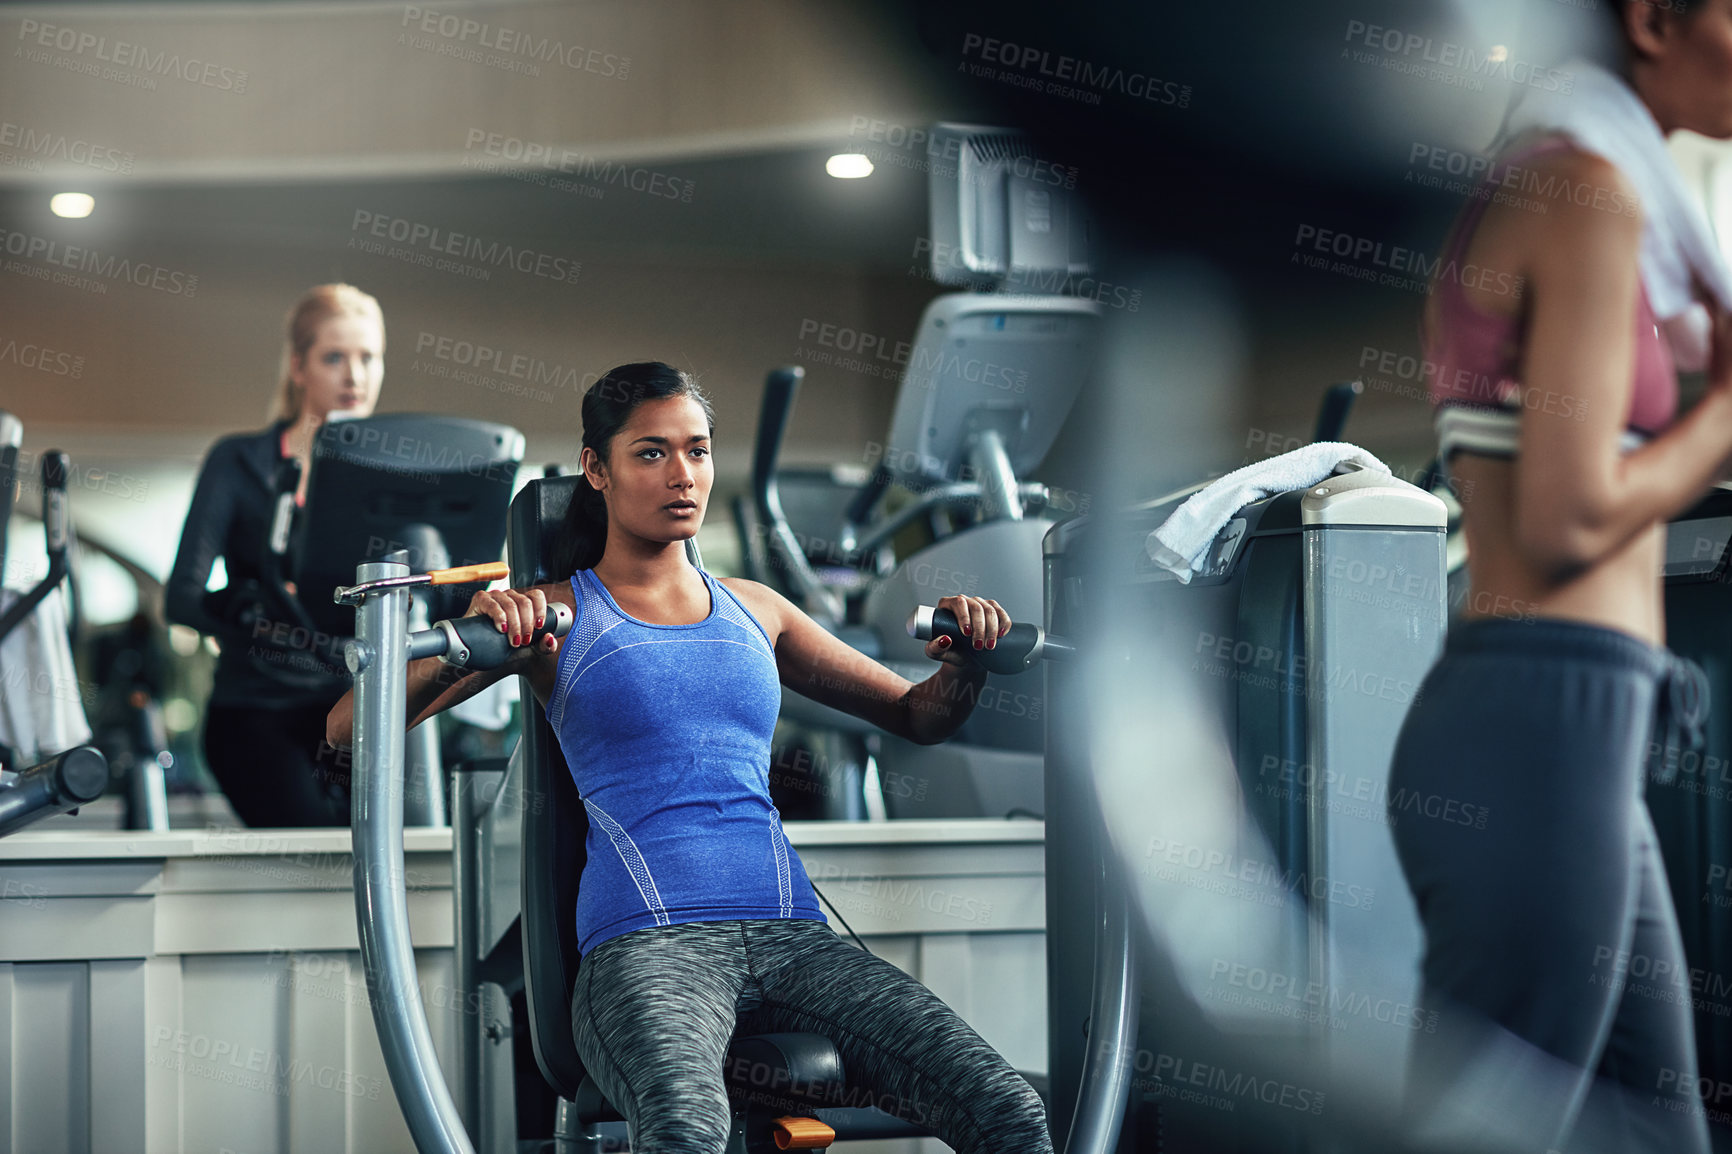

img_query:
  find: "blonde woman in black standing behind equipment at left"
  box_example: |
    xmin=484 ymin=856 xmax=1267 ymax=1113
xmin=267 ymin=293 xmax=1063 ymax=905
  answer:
xmin=166 ymin=284 xmax=385 ymax=827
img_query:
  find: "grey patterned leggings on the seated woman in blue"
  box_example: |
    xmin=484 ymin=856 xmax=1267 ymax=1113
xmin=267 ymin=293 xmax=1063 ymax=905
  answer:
xmin=572 ymin=918 xmax=1053 ymax=1154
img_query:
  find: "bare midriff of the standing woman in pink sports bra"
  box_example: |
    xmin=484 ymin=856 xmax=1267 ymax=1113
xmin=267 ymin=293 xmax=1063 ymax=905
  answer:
xmin=1450 ymin=452 xmax=1666 ymax=645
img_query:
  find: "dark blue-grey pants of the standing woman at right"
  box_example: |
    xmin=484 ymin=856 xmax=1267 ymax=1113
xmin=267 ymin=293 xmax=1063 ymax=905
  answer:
xmin=1389 ymin=619 xmax=1708 ymax=1154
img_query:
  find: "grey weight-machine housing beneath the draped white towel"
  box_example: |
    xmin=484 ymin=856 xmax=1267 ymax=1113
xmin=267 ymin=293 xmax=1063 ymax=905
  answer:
xmin=1044 ymin=443 xmax=1446 ymax=1154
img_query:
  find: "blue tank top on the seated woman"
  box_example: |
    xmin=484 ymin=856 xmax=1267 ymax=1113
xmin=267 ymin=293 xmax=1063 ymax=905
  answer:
xmin=547 ymin=568 xmax=824 ymax=953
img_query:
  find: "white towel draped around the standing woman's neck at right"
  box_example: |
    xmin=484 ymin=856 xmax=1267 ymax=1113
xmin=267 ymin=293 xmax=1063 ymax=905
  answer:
xmin=1500 ymin=59 xmax=1732 ymax=371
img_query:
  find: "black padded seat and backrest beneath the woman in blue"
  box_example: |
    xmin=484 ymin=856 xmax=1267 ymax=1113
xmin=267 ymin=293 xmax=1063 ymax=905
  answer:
xmin=507 ymin=477 xmax=843 ymax=1125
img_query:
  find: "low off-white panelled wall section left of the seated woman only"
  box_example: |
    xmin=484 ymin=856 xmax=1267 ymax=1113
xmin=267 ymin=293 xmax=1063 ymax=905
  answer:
xmin=0 ymin=830 xmax=459 ymax=1154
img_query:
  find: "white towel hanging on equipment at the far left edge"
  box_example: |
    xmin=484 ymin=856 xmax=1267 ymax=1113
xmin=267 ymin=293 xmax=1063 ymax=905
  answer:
xmin=0 ymin=589 xmax=90 ymax=771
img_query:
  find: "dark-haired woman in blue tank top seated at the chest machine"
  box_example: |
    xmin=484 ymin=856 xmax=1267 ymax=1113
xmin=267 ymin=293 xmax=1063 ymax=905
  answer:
xmin=331 ymin=362 xmax=1053 ymax=1154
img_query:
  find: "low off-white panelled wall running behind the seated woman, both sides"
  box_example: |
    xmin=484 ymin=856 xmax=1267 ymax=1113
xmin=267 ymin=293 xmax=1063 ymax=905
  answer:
xmin=0 ymin=821 xmax=1046 ymax=1154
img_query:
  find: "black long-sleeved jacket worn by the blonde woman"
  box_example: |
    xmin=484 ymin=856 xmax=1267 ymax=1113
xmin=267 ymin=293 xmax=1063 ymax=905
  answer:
xmin=165 ymin=423 xmax=348 ymax=709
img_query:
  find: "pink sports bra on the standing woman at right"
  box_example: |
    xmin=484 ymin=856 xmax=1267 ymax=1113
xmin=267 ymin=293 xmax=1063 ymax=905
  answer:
xmin=1425 ymin=139 xmax=1678 ymax=459
